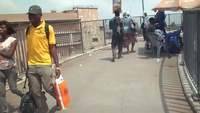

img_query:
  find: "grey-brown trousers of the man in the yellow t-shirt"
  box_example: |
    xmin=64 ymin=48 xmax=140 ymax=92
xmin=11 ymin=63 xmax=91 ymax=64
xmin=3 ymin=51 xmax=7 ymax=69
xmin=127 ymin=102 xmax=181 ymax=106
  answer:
xmin=28 ymin=66 xmax=55 ymax=113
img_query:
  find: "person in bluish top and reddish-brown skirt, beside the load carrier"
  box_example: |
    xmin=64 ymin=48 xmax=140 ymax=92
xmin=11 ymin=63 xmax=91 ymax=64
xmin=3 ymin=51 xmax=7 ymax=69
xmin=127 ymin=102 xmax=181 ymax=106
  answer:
xmin=123 ymin=12 xmax=136 ymax=53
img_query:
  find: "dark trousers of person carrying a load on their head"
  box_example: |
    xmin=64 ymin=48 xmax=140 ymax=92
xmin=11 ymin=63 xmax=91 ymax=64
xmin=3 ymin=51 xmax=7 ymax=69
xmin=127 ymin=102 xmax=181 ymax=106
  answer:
xmin=111 ymin=36 xmax=123 ymax=59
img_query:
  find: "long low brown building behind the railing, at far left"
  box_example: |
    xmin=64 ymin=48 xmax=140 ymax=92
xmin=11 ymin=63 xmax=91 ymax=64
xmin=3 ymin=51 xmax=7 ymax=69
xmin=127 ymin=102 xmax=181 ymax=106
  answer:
xmin=0 ymin=13 xmax=82 ymax=75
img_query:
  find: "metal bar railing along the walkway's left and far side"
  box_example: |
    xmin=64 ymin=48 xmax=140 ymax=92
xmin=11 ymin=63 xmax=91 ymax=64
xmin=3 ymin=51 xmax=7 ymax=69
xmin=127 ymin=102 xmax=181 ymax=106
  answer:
xmin=13 ymin=14 xmax=182 ymax=75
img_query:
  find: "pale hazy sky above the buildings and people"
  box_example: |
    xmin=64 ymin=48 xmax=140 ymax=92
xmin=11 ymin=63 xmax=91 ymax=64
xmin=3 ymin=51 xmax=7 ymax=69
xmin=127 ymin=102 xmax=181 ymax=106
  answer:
xmin=0 ymin=0 xmax=160 ymax=19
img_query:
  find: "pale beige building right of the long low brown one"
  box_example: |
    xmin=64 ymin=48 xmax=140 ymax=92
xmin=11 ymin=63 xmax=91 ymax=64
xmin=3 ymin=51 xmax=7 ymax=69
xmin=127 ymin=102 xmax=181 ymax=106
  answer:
xmin=63 ymin=7 xmax=104 ymax=50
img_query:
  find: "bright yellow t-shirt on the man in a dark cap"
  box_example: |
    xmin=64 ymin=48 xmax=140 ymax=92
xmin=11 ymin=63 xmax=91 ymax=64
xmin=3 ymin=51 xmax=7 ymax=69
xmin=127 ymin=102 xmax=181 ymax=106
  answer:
xmin=26 ymin=21 xmax=56 ymax=65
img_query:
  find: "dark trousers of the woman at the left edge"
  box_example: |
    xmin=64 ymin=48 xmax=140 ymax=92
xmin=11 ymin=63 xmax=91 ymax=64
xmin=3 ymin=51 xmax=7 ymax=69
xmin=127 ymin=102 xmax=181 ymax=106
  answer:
xmin=0 ymin=68 xmax=23 ymax=113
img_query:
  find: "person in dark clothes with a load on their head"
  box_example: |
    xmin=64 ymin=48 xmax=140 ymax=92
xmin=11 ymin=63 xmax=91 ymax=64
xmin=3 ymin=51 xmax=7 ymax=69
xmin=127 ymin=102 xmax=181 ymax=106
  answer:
xmin=109 ymin=10 xmax=124 ymax=62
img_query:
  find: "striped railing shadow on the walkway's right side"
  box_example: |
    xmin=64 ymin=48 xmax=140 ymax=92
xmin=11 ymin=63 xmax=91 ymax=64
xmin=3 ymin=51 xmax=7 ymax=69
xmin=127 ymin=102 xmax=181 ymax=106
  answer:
xmin=159 ymin=57 xmax=193 ymax=113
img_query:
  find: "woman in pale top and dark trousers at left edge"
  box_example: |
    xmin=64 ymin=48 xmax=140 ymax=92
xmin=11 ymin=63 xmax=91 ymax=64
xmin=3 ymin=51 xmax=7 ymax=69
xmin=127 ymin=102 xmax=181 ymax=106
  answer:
xmin=0 ymin=20 xmax=24 ymax=113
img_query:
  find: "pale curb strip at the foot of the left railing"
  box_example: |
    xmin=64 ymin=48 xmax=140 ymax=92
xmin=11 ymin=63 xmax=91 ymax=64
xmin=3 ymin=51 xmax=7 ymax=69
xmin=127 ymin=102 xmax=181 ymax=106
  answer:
xmin=6 ymin=45 xmax=111 ymax=90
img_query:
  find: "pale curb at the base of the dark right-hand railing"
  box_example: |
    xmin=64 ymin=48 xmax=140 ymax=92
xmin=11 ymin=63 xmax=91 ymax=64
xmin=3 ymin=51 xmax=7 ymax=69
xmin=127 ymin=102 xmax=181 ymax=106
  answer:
xmin=177 ymin=54 xmax=200 ymax=113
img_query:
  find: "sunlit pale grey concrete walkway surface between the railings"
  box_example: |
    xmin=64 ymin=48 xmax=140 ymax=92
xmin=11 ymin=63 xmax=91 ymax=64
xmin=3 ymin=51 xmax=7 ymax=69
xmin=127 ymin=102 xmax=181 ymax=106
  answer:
xmin=7 ymin=42 xmax=190 ymax=113
